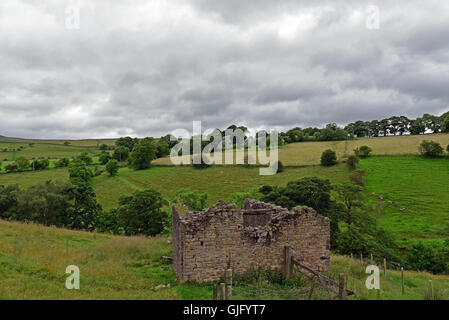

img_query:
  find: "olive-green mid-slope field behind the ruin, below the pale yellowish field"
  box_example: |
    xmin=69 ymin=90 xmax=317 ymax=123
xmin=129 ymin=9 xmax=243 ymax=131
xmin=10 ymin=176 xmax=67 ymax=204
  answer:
xmin=0 ymin=165 xmax=349 ymax=208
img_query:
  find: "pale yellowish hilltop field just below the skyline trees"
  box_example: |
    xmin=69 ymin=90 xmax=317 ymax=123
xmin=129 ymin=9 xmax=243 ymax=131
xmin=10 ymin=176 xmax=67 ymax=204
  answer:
xmin=154 ymin=134 xmax=449 ymax=166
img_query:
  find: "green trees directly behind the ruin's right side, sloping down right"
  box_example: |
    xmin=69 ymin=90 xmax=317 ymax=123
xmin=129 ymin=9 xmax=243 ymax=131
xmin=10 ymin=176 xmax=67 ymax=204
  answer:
xmin=259 ymin=178 xmax=400 ymax=261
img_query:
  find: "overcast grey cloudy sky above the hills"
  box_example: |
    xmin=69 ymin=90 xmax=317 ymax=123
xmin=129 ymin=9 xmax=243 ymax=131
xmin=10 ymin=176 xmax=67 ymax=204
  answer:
xmin=0 ymin=0 xmax=449 ymax=139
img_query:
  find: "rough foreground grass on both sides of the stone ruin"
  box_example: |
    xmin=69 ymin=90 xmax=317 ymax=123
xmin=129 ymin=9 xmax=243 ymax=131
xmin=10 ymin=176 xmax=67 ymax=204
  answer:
xmin=0 ymin=221 xmax=449 ymax=300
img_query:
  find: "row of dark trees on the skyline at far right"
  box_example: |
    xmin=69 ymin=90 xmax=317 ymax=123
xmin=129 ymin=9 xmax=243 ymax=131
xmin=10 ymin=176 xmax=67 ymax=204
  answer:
xmin=345 ymin=112 xmax=449 ymax=137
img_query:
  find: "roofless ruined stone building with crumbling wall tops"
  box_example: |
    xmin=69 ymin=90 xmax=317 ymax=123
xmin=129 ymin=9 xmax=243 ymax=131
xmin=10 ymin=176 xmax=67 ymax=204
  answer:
xmin=173 ymin=199 xmax=330 ymax=282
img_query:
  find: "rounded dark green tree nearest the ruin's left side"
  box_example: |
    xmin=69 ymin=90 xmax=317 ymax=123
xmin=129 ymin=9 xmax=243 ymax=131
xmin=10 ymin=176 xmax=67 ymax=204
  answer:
xmin=117 ymin=189 xmax=168 ymax=236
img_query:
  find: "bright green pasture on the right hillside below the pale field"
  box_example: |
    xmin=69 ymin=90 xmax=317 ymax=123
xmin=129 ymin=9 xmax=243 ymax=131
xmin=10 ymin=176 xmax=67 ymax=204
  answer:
xmin=359 ymin=156 xmax=449 ymax=242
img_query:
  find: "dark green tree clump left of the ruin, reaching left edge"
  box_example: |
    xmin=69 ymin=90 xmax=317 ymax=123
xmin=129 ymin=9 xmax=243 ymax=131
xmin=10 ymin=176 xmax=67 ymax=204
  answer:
xmin=0 ymin=159 xmax=168 ymax=236
